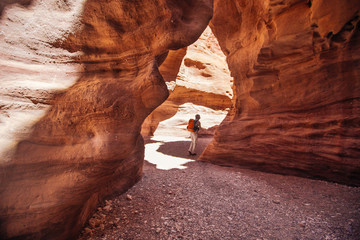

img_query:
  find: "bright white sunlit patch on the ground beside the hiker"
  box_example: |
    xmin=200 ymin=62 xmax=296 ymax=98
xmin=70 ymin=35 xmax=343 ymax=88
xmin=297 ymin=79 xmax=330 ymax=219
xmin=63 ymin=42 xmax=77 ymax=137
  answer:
xmin=145 ymin=136 xmax=194 ymax=170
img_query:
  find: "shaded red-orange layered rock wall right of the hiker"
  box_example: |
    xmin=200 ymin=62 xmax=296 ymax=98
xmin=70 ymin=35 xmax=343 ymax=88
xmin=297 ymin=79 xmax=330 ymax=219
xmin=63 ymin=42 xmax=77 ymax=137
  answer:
xmin=201 ymin=0 xmax=360 ymax=186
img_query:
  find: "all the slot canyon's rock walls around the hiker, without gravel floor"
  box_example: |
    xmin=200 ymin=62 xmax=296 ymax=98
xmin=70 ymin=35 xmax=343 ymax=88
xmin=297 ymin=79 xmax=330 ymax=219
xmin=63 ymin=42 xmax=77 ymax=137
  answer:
xmin=0 ymin=0 xmax=360 ymax=239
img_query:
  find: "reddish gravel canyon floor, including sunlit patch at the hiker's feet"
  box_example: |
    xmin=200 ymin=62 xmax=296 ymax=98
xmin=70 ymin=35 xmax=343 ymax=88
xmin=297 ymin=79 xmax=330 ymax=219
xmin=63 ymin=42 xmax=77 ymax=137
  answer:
xmin=78 ymin=137 xmax=360 ymax=240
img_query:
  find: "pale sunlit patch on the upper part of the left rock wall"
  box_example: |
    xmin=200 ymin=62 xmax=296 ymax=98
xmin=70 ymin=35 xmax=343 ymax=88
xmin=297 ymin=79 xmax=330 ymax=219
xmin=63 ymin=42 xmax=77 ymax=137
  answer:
xmin=0 ymin=0 xmax=85 ymax=163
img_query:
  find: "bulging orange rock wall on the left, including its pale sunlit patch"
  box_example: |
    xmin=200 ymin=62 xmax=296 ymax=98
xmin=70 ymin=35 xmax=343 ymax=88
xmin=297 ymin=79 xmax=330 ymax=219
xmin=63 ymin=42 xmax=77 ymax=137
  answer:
xmin=0 ymin=0 xmax=212 ymax=239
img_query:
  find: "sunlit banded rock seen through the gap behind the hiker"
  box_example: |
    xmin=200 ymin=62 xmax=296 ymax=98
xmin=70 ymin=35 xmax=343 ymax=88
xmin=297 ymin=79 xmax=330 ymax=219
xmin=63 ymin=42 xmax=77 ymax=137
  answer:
xmin=142 ymin=27 xmax=233 ymax=136
